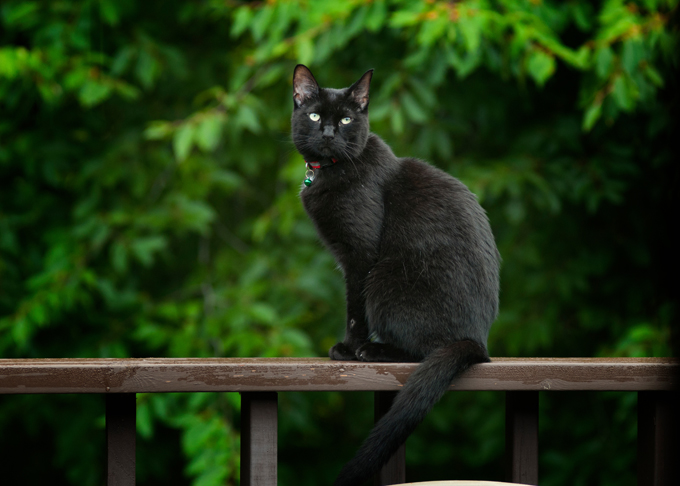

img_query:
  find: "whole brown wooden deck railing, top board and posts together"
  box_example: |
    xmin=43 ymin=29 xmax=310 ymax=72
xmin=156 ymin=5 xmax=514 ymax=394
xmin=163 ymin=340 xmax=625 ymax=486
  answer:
xmin=0 ymin=358 xmax=680 ymax=486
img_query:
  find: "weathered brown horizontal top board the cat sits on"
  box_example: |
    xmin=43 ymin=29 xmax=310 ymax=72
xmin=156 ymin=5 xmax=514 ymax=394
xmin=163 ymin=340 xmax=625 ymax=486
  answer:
xmin=0 ymin=358 xmax=680 ymax=394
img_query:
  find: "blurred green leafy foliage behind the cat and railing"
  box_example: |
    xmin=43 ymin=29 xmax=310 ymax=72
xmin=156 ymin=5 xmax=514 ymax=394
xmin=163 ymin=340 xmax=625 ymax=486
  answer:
xmin=0 ymin=0 xmax=679 ymax=486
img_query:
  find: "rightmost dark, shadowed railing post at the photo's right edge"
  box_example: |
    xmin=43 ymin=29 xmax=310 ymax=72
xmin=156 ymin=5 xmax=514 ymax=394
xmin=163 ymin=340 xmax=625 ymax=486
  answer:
xmin=637 ymin=391 xmax=680 ymax=486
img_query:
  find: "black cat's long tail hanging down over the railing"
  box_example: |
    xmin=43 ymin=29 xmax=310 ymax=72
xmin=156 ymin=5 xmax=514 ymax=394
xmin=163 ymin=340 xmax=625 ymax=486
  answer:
xmin=334 ymin=341 xmax=489 ymax=486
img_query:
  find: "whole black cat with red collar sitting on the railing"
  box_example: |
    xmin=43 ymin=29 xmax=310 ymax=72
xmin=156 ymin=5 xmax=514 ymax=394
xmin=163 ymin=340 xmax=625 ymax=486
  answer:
xmin=292 ymin=64 xmax=500 ymax=486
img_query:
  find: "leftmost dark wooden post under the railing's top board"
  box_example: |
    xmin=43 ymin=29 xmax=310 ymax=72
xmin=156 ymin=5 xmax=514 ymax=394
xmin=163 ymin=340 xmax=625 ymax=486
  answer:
xmin=106 ymin=393 xmax=137 ymax=486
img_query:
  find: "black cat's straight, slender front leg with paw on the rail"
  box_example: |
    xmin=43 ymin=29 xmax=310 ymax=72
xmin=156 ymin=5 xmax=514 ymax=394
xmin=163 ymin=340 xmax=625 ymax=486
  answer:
xmin=328 ymin=275 xmax=369 ymax=361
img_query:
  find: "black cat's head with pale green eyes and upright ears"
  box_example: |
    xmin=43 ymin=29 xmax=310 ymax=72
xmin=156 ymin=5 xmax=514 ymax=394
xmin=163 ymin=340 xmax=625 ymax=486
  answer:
xmin=291 ymin=64 xmax=373 ymax=161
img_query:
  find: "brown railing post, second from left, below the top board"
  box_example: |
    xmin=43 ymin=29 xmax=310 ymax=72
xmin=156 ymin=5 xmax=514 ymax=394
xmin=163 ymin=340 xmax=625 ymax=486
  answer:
xmin=241 ymin=392 xmax=278 ymax=486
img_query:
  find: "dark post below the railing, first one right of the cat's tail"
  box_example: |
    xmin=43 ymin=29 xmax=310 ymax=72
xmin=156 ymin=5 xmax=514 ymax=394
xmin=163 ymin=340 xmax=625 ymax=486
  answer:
xmin=505 ymin=391 xmax=538 ymax=484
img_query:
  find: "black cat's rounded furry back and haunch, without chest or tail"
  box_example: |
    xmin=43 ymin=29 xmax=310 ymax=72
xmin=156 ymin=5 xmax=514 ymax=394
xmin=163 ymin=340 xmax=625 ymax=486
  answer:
xmin=366 ymin=158 xmax=500 ymax=342
